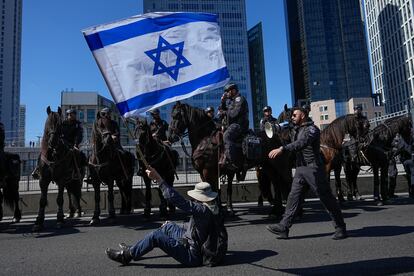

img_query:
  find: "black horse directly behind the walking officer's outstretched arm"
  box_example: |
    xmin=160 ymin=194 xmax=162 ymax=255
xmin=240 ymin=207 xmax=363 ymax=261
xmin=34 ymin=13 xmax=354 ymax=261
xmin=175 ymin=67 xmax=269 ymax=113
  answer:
xmin=256 ymin=105 xmax=293 ymax=217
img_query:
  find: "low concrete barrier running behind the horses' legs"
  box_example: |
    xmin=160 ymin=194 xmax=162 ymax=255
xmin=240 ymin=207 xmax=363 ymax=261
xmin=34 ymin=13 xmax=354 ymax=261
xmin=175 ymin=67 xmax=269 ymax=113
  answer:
xmin=4 ymin=175 xmax=408 ymax=216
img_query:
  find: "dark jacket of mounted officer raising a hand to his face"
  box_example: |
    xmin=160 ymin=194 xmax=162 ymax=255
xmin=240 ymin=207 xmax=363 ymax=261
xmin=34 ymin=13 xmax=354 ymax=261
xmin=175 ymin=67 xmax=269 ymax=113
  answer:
xmin=221 ymin=95 xmax=249 ymax=131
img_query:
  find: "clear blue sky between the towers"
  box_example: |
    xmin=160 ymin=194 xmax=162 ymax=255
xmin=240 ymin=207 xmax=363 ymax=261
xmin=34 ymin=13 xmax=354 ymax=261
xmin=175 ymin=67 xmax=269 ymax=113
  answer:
xmin=20 ymin=0 xmax=291 ymax=143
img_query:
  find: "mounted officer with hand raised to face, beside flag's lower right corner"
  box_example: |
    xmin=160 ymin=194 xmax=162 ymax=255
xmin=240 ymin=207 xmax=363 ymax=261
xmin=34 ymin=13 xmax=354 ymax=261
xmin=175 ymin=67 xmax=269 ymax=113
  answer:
xmin=220 ymin=83 xmax=249 ymax=171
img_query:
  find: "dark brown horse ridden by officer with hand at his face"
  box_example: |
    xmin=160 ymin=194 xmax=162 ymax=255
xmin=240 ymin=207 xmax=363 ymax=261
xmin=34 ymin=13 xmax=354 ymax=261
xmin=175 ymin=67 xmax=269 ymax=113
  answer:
xmin=168 ymin=102 xmax=247 ymax=213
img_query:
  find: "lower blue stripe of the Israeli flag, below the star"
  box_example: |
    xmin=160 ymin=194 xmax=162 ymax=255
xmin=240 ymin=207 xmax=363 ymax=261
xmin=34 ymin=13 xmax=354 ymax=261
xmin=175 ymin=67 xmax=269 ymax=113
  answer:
xmin=117 ymin=67 xmax=230 ymax=115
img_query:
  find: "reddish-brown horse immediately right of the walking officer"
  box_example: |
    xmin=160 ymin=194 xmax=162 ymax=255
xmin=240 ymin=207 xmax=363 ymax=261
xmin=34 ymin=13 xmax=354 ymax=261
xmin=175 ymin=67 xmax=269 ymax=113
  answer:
xmin=320 ymin=114 xmax=369 ymax=201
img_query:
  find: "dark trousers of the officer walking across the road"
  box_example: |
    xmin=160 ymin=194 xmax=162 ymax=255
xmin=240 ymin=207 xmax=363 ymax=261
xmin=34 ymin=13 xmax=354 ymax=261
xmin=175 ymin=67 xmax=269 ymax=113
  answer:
xmin=280 ymin=166 xmax=345 ymax=228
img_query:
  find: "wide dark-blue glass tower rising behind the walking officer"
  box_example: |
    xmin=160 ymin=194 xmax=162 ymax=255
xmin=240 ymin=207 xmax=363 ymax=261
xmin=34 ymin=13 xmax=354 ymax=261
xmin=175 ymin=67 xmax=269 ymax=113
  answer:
xmin=284 ymin=0 xmax=372 ymax=116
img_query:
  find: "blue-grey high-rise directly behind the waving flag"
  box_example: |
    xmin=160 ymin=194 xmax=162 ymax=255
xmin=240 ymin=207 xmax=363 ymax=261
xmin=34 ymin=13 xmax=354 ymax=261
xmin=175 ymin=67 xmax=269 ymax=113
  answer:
xmin=144 ymin=0 xmax=253 ymax=127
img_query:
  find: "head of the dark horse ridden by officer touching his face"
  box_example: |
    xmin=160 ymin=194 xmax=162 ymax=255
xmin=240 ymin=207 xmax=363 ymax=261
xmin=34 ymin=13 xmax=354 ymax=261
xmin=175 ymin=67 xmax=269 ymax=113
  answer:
xmin=168 ymin=102 xmax=188 ymax=143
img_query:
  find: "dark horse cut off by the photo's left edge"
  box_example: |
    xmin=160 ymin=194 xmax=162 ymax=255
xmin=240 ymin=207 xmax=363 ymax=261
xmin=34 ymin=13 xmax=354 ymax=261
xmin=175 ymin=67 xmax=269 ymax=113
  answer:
xmin=0 ymin=152 xmax=22 ymax=223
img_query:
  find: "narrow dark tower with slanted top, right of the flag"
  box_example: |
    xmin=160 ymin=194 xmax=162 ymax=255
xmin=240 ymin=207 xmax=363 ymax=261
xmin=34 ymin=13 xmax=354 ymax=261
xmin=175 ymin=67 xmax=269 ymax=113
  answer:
xmin=247 ymin=22 xmax=267 ymax=131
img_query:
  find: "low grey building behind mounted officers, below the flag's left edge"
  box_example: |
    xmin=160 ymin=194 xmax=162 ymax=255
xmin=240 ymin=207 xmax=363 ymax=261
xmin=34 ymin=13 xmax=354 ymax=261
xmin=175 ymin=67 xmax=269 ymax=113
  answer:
xmin=61 ymin=91 xmax=135 ymax=147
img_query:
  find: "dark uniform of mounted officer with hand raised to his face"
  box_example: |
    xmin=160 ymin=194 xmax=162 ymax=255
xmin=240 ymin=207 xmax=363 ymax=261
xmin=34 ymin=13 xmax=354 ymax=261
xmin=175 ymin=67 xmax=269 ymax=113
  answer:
xmin=221 ymin=88 xmax=249 ymax=164
